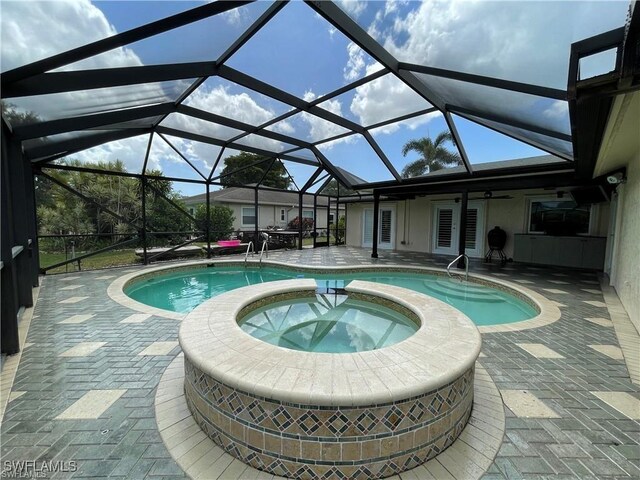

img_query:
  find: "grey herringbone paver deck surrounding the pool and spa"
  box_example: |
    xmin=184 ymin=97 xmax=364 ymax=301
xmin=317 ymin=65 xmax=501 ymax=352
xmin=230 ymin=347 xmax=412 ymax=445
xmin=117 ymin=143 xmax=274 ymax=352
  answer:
xmin=0 ymin=247 xmax=640 ymax=479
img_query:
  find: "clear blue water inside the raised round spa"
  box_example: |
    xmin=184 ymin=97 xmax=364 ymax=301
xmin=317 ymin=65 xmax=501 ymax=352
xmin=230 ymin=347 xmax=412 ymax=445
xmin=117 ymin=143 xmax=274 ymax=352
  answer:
xmin=238 ymin=294 xmax=418 ymax=353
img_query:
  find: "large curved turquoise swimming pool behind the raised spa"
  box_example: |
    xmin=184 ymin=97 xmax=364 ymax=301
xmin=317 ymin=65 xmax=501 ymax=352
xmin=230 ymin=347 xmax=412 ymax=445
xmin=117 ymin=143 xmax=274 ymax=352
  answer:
xmin=124 ymin=264 xmax=538 ymax=326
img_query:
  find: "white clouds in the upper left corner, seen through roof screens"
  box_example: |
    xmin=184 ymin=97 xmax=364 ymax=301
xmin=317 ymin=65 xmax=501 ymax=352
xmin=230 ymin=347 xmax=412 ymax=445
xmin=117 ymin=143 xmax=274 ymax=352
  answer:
xmin=0 ymin=0 xmax=158 ymax=124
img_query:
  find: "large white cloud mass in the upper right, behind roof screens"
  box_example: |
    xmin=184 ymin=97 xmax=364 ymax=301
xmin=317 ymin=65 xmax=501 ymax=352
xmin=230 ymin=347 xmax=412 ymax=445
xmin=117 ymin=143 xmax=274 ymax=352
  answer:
xmin=345 ymin=0 xmax=625 ymax=139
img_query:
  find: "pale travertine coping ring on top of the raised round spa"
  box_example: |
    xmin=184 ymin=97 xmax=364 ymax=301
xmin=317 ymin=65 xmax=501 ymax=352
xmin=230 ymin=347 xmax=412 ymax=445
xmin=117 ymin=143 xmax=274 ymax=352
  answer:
xmin=179 ymin=279 xmax=481 ymax=406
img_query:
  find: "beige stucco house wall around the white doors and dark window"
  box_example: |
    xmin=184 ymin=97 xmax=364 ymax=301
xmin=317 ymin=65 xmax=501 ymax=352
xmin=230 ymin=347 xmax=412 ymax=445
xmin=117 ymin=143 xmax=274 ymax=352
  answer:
xmin=347 ymin=190 xmax=609 ymax=257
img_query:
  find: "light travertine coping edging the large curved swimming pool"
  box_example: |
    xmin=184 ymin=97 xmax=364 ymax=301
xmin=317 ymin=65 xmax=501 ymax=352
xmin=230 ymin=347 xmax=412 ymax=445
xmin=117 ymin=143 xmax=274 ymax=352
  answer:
xmin=107 ymin=259 xmax=561 ymax=333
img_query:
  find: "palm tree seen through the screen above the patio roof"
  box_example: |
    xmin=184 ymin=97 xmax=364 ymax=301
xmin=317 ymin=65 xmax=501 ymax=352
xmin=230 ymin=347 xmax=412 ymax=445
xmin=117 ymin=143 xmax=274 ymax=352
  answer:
xmin=402 ymin=132 xmax=462 ymax=178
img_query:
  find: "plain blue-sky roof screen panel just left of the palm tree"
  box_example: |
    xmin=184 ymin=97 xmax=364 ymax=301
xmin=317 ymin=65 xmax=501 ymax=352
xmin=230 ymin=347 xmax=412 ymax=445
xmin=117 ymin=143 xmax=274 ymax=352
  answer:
xmin=318 ymin=134 xmax=394 ymax=182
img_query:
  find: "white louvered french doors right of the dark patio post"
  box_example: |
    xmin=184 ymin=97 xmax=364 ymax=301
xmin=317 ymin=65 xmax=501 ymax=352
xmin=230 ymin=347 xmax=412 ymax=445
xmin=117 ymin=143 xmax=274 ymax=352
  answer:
xmin=432 ymin=202 xmax=484 ymax=257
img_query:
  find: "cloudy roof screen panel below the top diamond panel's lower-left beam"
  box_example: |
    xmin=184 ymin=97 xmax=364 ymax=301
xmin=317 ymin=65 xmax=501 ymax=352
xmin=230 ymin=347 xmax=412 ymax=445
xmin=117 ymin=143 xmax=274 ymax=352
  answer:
xmin=184 ymin=77 xmax=292 ymax=125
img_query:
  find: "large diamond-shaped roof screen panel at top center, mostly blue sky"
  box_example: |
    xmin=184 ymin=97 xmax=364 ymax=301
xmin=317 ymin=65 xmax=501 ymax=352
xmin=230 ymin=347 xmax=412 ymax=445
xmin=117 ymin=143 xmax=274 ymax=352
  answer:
xmin=227 ymin=2 xmax=375 ymax=100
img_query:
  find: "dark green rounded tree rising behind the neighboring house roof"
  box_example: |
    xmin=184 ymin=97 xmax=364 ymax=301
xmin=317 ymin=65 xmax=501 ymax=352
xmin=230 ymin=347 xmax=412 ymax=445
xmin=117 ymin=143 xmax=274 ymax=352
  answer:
xmin=220 ymin=152 xmax=291 ymax=190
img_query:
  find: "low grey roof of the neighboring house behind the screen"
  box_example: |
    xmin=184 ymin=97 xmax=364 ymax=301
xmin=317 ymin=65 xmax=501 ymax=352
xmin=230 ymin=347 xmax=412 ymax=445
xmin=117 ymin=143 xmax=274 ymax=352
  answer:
xmin=182 ymin=187 xmax=340 ymax=208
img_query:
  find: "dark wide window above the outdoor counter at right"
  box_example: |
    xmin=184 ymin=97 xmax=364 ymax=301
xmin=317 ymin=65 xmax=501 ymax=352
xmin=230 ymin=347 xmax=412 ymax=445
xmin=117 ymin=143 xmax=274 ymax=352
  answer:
xmin=529 ymin=198 xmax=591 ymax=235
